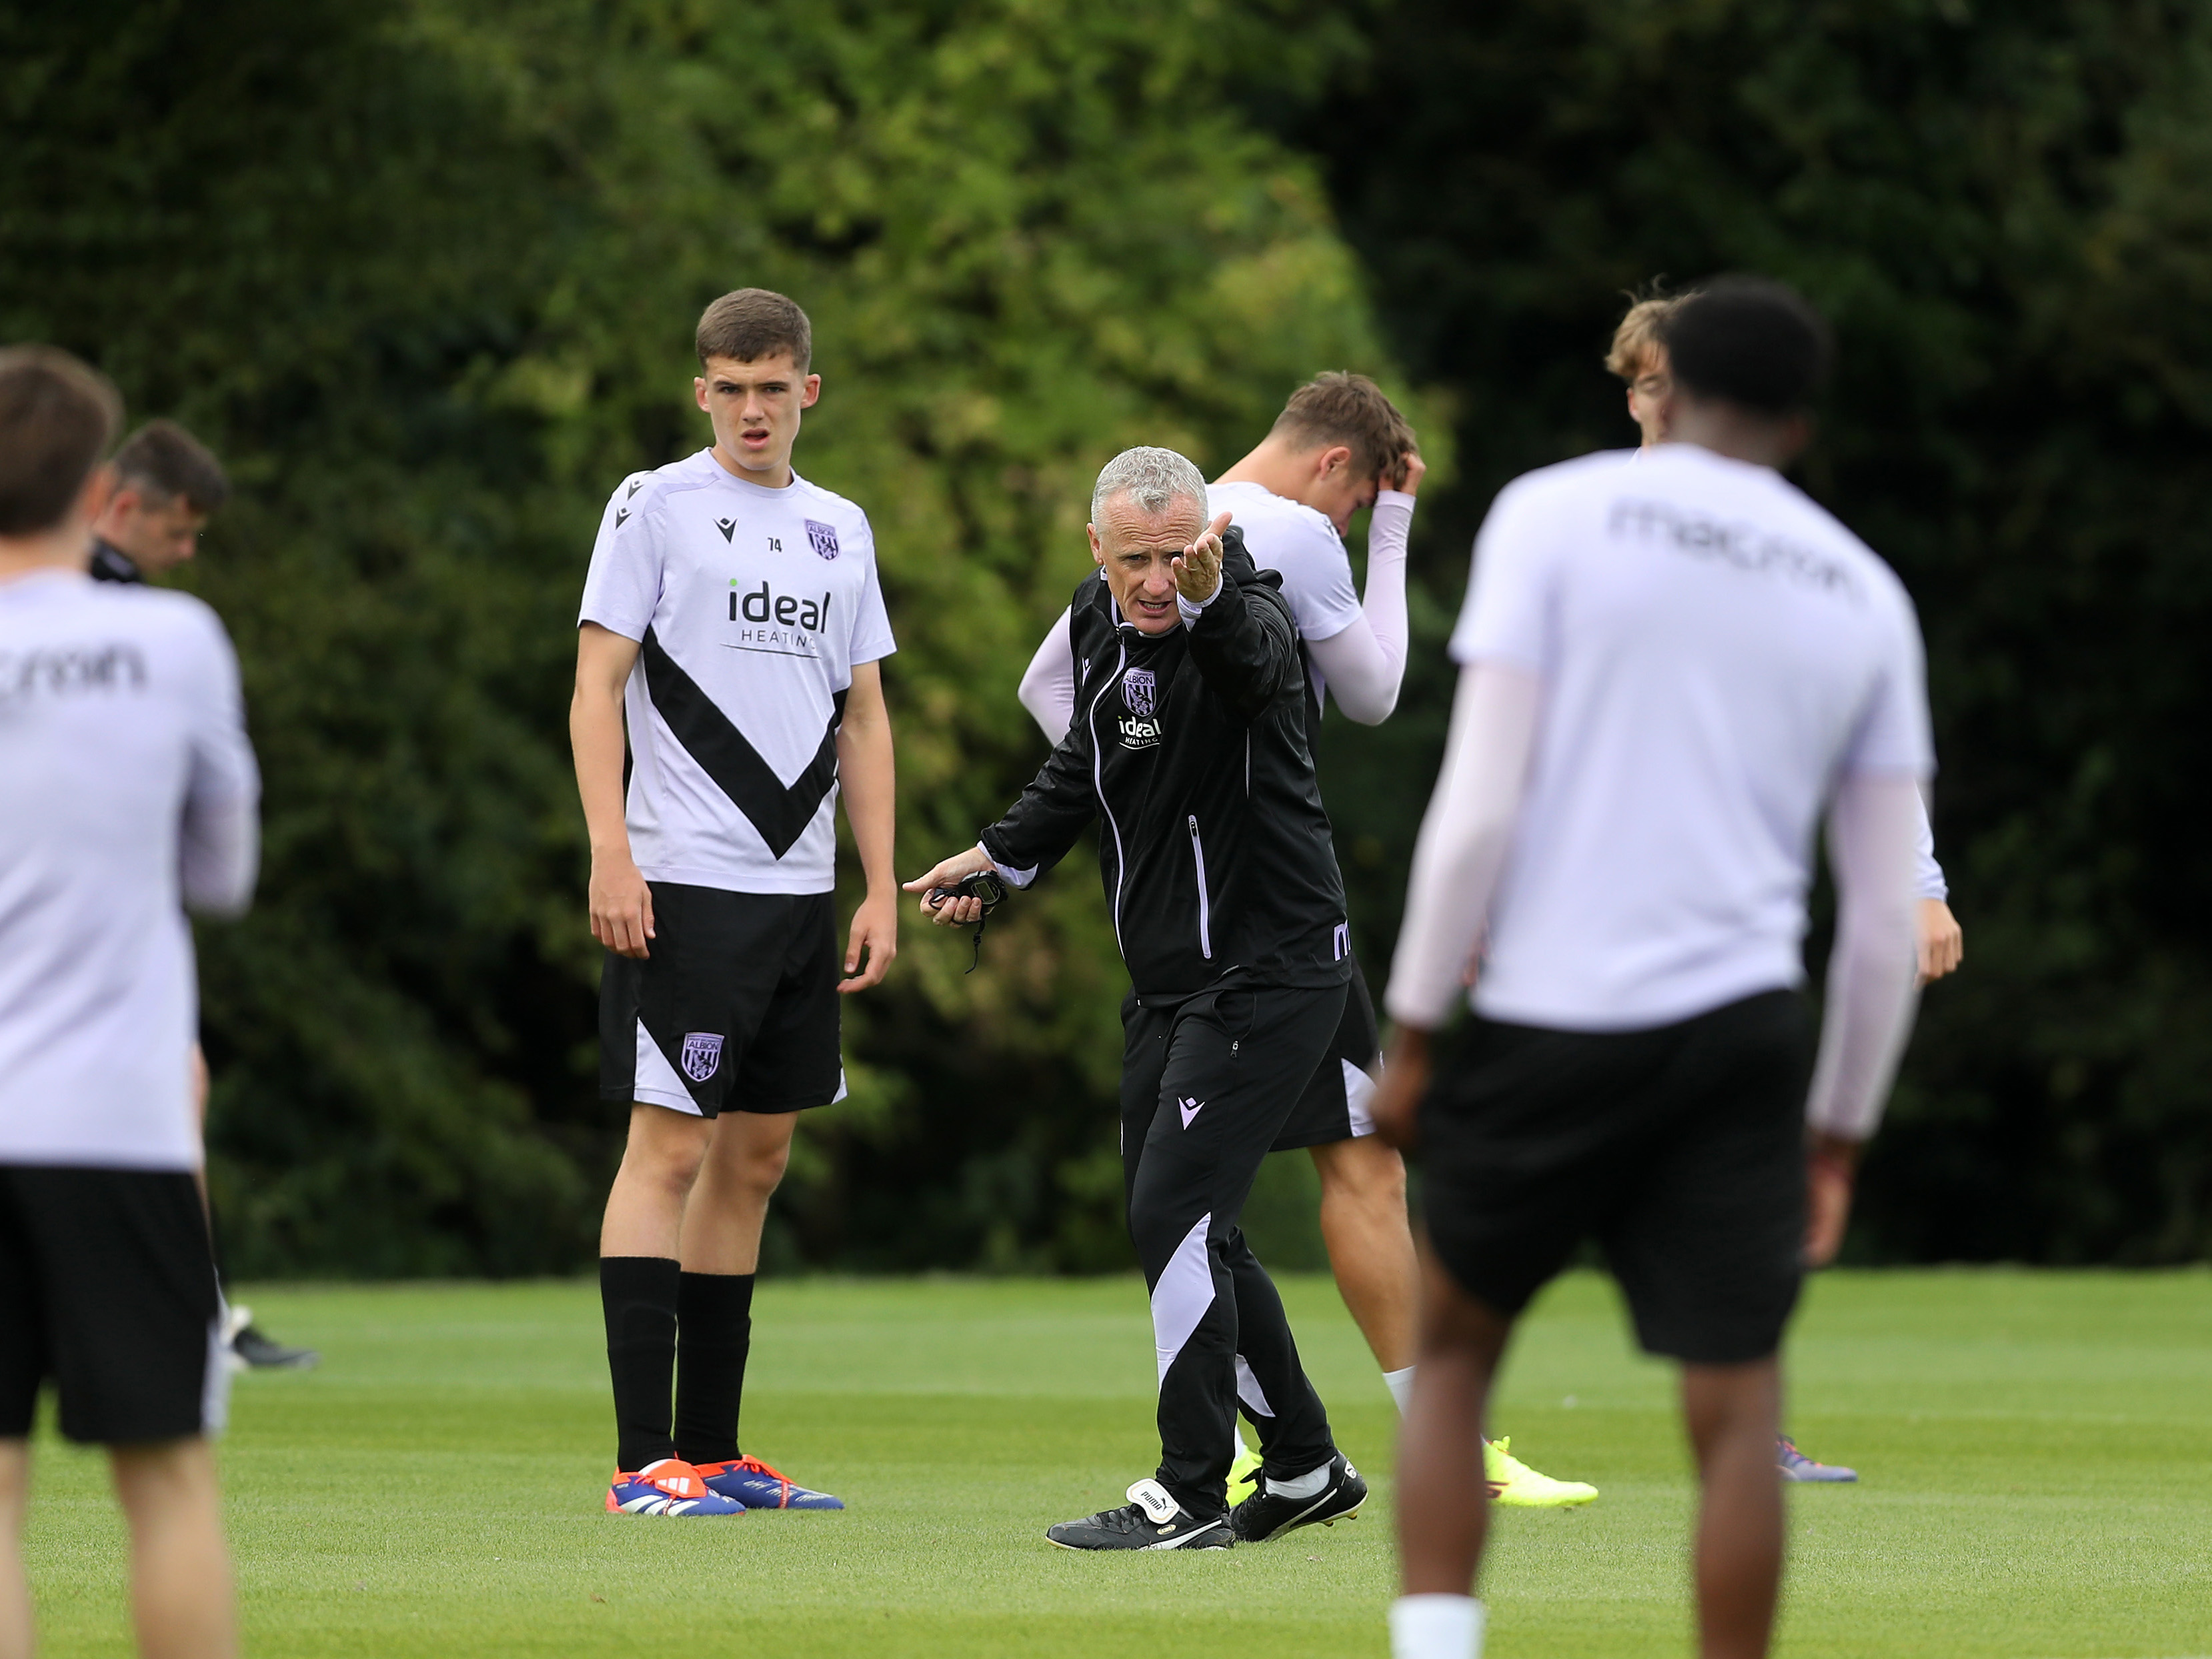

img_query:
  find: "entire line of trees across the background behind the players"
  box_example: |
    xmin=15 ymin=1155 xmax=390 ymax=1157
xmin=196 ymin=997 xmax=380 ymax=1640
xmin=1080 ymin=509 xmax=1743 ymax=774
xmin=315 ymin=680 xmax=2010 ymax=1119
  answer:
xmin=0 ymin=0 xmax=2212 ymax=1272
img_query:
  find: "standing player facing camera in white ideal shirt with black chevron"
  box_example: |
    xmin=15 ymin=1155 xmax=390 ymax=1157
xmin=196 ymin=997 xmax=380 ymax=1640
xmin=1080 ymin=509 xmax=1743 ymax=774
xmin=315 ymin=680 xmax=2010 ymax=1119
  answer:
xmin=568 ymin=287 xmax=898 ymax=1515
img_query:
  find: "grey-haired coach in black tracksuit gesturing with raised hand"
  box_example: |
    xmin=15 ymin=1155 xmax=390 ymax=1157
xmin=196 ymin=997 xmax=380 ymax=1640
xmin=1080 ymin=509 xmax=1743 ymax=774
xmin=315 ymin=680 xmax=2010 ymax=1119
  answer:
xmin=912 ymin=449 xmax=1365 ymax=1548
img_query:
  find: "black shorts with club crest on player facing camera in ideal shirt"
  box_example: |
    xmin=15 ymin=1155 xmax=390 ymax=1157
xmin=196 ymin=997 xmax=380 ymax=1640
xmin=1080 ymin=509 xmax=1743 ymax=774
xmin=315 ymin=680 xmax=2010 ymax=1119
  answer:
xmin=600 ymin=880 xmax=845 ymax=1117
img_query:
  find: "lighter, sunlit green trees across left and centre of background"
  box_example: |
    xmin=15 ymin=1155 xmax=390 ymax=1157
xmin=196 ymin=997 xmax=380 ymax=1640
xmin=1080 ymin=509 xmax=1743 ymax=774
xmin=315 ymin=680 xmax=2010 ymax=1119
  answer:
xmin=0 ymin=0 xmax=1378 ymax=1272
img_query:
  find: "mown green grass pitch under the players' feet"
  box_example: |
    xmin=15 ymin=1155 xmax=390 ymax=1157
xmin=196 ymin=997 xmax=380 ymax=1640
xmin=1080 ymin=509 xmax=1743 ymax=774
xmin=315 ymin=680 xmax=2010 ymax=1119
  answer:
xmin=29 ymin=1272 xmax=2212 ymax=1659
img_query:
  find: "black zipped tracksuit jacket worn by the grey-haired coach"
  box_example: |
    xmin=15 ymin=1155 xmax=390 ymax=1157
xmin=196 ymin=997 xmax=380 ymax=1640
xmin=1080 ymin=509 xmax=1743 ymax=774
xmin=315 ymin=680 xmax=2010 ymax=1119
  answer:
xmin=982 ymin=527 xmax=1352 ymax=1004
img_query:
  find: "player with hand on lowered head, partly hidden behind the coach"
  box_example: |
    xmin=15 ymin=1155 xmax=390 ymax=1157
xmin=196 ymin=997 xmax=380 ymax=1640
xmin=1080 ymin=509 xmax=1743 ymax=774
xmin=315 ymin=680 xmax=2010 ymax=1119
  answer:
xmin=1020 ymin=374 xmax=1597 ymax=1506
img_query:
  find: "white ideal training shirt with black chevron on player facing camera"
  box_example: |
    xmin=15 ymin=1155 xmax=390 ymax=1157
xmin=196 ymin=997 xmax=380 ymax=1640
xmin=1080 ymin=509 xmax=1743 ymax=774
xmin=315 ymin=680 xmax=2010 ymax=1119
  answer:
xmin=580 ymin=449 xmax=896 ymax=894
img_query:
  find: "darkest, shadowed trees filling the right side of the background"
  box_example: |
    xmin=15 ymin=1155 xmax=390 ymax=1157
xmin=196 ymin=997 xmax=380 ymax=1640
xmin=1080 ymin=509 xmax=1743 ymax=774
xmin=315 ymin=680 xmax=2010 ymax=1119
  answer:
xmin=1290 ymin=0 xmax=2212 ymax=1261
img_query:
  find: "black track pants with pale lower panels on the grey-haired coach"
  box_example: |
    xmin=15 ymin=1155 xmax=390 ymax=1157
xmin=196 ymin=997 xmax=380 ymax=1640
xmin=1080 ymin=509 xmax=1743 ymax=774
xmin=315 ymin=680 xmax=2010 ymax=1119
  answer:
xmin=1122 ymin=984 xmax=1345 ymax=1518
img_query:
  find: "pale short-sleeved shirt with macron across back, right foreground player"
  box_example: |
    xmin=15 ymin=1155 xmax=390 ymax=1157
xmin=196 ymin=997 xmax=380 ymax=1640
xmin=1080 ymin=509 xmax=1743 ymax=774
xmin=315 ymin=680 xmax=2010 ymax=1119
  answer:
xmin=1451 ymin=445 xmax=1933 ymax=1031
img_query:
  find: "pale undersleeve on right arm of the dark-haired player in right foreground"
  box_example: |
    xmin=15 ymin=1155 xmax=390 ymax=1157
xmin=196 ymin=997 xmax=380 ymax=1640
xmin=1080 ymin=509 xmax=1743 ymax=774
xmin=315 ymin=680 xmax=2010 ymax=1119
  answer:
xmin=1805 ymin=779 xmax=1918 ymax=1142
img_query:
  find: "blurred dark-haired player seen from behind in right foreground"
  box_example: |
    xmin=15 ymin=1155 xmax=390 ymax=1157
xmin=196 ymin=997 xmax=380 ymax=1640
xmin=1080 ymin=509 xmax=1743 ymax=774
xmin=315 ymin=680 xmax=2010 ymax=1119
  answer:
xmin=1376 ymin=279 xmax=1931 ymax=1659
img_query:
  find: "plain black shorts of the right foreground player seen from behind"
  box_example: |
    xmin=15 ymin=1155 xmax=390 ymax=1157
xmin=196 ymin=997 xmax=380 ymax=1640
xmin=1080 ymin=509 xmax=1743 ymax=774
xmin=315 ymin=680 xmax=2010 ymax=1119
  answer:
xmin=1420 ymin=991 xmax=1812 ymax=1365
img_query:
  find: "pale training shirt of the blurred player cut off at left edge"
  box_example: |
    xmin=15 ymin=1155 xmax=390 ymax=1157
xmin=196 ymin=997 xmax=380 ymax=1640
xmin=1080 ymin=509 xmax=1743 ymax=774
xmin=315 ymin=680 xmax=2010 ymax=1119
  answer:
xmin=0 ymin=571 xmax=259 ymax=1170
